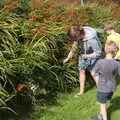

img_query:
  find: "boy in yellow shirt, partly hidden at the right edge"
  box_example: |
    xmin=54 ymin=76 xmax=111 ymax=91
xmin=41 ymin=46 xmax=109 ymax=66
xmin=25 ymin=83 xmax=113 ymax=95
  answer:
xmin=104 ymin=22 xmax=120 ymax=61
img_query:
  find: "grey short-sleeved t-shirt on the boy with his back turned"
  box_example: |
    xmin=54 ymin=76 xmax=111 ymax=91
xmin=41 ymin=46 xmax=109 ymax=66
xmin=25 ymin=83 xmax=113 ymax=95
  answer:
xmin=92 ymin=59 xmax=120 ymax=93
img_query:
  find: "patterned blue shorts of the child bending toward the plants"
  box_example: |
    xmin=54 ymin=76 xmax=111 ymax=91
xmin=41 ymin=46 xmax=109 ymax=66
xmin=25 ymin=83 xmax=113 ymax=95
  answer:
xmin=78 ymin=58 xmax=97 ymax=71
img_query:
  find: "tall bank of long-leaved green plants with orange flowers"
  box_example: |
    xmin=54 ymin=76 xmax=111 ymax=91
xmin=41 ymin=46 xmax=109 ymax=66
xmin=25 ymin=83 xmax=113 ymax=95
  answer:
xmin=0 ymin=0 xmax=119 ymax=117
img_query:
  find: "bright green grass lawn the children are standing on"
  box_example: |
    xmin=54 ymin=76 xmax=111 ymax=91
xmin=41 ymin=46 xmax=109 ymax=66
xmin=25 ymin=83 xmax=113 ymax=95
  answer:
xmin=28 ymin=85 xmax=120 ymax=120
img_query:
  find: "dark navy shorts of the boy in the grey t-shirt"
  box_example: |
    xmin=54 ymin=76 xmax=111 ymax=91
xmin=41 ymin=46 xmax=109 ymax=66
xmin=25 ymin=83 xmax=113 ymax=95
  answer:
xmin=97 ymin=92 xmax=113 ymax=104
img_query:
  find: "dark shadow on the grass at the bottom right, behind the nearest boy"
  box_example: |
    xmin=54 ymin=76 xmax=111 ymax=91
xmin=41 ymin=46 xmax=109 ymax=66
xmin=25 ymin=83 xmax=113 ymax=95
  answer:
xmin=108 ymin=97 xmax=120 ymax=120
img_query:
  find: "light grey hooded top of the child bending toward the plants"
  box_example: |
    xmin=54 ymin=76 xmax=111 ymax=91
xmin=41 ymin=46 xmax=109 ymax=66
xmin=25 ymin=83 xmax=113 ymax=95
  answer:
xmin=73 ymin=26 xmax=102 ymax=58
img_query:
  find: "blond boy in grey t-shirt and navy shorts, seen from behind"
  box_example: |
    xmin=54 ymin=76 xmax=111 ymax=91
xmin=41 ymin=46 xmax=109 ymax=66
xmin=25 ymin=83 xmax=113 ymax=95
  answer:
xmin=92 ymin=41 xmax=120 ymax=120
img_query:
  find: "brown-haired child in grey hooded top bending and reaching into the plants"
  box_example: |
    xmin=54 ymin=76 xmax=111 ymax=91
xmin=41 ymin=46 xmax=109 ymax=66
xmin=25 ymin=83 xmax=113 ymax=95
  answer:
xmin=64 ymin=25 xmax=102 ymax=97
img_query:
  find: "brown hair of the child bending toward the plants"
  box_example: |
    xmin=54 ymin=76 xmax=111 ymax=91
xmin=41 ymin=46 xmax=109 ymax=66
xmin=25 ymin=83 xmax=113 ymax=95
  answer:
xmin=67 ymin=25 xmax=85 ymax=41
